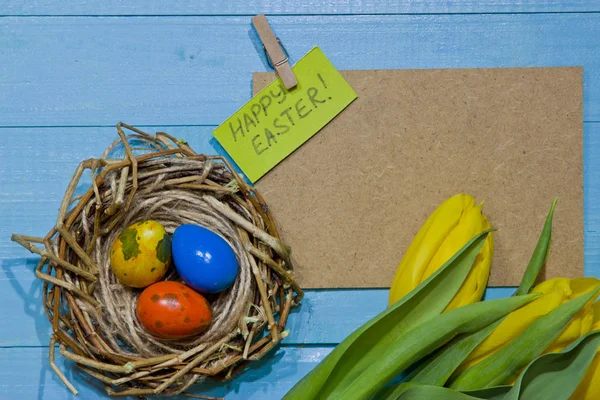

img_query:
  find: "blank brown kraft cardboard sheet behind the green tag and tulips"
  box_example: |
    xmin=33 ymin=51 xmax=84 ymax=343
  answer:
xmin=253 ymin=67 xmax=583 ymax=288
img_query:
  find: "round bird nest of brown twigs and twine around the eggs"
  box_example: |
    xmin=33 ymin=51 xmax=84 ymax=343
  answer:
xmin=12 ymin=123 xmax=303 ymax=396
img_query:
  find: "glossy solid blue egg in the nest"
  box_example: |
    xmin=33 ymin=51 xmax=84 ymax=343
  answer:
xmin=171 ymin=224 xmax=238 ymax=293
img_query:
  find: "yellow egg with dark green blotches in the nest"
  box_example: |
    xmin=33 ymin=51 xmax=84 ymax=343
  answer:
xmin=110 ymin=220 xmax=171 ymax=288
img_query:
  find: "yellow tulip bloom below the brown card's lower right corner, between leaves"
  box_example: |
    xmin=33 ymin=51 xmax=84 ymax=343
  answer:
xmin=455 ymin=278 xmax=600 ymax=374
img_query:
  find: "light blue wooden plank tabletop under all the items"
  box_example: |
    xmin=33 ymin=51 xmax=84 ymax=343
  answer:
xmin=0 ymin=0 xmax=600 ymax=400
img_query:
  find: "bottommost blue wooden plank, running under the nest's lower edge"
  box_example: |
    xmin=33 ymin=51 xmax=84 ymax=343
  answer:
xmin=0 ymin=347 xmax=331 ymax=400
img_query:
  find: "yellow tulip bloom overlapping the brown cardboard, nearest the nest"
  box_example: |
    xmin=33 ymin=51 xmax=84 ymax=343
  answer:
xmin=389 ymin=194 xmax=494 ymax=311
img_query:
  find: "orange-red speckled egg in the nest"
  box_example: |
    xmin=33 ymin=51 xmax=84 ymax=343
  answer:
xmin=136 ymin=281 xmax=212 ymax=339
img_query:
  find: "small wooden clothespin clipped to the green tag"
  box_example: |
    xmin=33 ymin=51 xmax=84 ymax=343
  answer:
xmin=252 ymin=14 xmax=298 ymax=89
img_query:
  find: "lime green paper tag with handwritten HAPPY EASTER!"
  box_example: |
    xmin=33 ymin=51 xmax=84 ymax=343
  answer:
xmin=213 ymin=47 xmax=357 ymax=183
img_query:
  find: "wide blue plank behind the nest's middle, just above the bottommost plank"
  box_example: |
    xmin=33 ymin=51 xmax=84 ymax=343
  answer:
xmin=0 ymin=123 xmax=600 ymax=346
